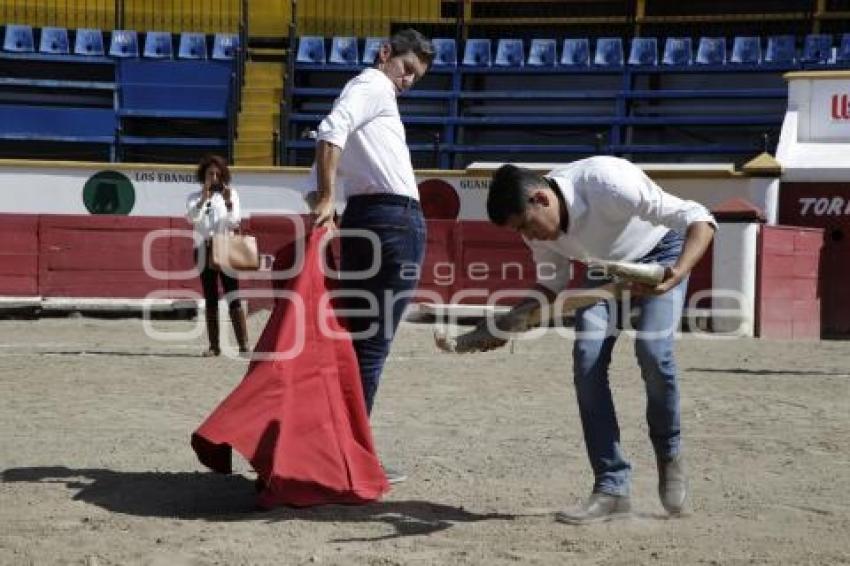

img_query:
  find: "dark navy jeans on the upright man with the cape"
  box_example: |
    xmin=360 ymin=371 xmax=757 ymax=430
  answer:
xmin=340 ymin=194 xmax=426 ymax=413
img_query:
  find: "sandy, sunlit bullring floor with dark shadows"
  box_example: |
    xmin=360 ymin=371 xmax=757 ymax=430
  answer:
xmin=0 ymin=315 xmax=850 ymax=566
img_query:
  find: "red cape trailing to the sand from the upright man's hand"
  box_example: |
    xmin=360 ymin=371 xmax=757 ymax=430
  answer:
xmin=192 ymin=230 xmax=389 ymax=507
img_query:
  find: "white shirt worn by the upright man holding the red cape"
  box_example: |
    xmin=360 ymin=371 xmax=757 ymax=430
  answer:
xmin=312 ymin=69 xmax=419 ymax=200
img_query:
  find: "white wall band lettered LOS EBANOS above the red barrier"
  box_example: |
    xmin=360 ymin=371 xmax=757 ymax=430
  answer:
xmin=0 ymin=160 xmax=776 ymax=223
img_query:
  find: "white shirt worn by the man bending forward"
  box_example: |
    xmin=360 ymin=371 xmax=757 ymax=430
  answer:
xmin=526 ymin=156 xmax=717 ymax=292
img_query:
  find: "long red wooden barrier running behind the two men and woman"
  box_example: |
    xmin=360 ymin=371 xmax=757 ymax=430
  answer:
xmin=0 ymin=215 xmax=711 ymax=316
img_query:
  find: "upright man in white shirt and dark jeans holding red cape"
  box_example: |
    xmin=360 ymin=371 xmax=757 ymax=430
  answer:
xmin=313 ymin=29 xmax=434 ymax=483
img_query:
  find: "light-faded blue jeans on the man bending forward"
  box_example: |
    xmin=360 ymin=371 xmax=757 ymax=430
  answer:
xmin=573 ymin=231 xmax=688 ymax=495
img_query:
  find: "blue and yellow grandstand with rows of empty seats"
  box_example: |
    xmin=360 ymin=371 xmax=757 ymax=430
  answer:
xmin=0 ymin=0 xmax=850 ymax=169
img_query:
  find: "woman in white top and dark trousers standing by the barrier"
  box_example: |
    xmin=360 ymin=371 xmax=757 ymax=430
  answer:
xmin=187 ymin=155 xmax=248 ymax=357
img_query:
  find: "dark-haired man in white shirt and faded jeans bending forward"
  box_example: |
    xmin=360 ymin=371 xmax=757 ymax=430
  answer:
xmin=487 ymin=157 xmax=717 ymax=524
